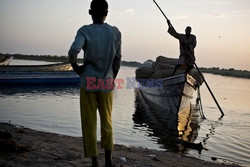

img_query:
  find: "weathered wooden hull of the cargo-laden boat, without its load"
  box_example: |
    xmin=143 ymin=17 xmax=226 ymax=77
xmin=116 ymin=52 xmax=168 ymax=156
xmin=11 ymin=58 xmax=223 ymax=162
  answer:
xmin=140 ymin=74 xmax=196 ymax=116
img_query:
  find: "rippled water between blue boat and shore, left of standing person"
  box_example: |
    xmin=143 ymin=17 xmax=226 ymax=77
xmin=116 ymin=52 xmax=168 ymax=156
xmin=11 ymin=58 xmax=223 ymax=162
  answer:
xmin=0 ymin=85 xmax=81 ymax=136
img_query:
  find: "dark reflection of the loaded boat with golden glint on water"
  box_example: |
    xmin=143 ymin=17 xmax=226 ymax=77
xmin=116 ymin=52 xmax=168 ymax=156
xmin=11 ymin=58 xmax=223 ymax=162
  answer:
xmin=133 ymin=90 xmax=203 ymax=154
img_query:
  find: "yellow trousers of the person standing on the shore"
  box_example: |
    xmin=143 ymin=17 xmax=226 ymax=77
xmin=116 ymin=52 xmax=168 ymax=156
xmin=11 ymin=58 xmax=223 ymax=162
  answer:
xmin=80 ymin=88 xmax=114 ymax=157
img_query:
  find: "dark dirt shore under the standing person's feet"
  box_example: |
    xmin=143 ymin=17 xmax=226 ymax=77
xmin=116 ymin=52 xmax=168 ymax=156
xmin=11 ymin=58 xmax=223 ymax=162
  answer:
xmin=0 ymin=123 xmax=238 ymax=167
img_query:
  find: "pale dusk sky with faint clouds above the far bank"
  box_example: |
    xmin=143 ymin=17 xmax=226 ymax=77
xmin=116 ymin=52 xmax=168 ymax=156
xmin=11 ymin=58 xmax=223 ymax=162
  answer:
xmin=0 ymin=0 xmax=250 ymax=70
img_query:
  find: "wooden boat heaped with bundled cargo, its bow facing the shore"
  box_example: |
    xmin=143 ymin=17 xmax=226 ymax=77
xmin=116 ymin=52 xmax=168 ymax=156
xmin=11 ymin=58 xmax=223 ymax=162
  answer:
xmin=136 ymin=56 xmax=202 ymax=118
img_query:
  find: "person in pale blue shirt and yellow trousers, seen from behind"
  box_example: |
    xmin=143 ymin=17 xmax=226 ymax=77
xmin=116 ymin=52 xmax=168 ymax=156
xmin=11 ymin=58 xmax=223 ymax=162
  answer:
xmin=68 ymin=0 xmax=121 ymax=167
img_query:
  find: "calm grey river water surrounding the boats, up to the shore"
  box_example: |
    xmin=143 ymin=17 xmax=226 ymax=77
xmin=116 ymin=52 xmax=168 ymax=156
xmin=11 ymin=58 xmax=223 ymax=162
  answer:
xmin=0 ymin=60 xmax=250 ymax=166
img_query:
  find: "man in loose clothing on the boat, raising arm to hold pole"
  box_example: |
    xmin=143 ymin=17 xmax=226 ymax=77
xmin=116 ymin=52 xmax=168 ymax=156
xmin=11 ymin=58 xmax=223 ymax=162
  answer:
xmin=167 ymin=20 xmax=197 ymax=76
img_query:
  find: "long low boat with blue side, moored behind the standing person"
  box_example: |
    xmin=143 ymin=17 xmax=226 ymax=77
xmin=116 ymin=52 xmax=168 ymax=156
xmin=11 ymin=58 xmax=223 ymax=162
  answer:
xmin=0 ymin=63 xmax=80 ymax=85
